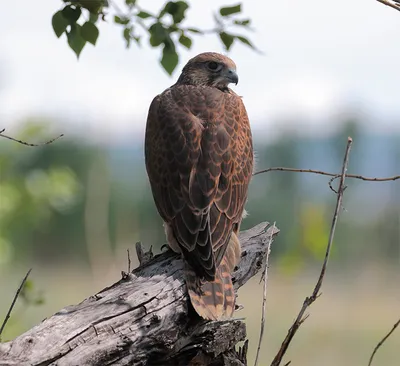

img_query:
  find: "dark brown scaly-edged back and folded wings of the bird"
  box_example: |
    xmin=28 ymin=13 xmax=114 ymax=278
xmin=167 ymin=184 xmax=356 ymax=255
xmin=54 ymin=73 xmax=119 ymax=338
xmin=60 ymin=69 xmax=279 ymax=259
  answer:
xmin=145 ymin=85 xmax=253 ymax=280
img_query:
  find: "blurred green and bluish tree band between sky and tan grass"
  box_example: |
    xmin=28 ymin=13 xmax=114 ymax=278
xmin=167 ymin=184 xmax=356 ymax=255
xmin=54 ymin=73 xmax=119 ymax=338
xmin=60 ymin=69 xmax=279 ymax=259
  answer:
xmin=0 ymin=116 xmax=400 ymax=271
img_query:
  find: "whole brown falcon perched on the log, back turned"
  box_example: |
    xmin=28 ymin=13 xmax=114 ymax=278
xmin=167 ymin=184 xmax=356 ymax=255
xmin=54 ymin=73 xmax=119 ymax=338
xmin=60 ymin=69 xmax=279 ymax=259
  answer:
xmin=145 ymin=52 xmax=253 ymax=320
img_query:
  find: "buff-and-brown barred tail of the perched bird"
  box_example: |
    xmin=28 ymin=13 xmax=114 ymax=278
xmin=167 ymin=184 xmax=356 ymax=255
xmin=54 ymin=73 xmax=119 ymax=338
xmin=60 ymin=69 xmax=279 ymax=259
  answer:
xmin=185 ymin=233 xmax=241 ymax=320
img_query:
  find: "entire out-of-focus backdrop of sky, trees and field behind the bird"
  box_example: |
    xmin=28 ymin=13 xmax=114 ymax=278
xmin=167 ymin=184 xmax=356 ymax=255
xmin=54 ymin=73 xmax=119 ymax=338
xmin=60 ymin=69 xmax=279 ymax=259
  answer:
xmin=0 ymin=0 xmax=400 ymax=366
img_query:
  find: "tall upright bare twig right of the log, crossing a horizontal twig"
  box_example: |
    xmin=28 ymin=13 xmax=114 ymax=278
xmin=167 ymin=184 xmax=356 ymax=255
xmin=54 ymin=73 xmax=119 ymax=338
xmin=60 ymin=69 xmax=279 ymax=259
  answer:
xmin=271 ymin=137 xmax=353 ymax=366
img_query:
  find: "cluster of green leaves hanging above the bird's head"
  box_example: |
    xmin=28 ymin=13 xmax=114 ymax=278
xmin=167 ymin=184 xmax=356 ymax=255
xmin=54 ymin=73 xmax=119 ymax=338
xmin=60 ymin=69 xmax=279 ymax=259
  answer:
xmin=52 ymin=0 xmax=256 ymax=75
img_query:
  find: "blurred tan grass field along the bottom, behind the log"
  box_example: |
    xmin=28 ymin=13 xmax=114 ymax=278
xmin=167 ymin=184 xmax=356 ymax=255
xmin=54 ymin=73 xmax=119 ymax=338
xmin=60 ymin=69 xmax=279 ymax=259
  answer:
xmin=0 ymin=260 xmax=400 ymax=366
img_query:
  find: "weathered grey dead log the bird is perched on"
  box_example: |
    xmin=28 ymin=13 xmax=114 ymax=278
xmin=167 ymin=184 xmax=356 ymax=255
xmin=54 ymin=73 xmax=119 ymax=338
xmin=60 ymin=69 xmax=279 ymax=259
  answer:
xmin=0 ymin=223 xmax=279 ymax=366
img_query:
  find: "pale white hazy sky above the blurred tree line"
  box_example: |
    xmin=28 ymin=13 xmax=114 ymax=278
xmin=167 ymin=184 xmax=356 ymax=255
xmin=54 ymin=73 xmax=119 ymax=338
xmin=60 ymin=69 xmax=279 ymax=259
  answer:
xmin=0 ymin=0 xmax=400 ymax=142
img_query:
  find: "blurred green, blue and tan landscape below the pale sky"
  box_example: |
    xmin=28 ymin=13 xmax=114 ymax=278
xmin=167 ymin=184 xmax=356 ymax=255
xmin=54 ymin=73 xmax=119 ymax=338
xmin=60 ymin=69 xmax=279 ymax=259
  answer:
xmin=0 ymin=119 xmax=400 ymax=365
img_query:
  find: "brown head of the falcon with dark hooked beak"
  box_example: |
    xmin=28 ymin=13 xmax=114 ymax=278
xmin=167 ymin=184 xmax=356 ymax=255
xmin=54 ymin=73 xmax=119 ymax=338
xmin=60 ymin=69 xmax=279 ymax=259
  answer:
xmin=177 ymin=52 xmax=239 ymax=91
